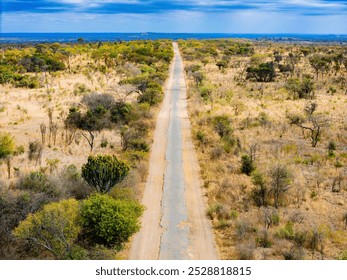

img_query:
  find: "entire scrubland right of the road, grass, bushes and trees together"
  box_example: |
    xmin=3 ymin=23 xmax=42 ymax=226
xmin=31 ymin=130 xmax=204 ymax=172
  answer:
xmin=179 ymin=40 xmax=347 ymax=260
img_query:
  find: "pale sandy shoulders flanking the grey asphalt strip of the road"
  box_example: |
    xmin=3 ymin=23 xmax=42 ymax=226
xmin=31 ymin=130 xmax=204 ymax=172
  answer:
xmin=129 ymin=43 xmax=218 ymax=259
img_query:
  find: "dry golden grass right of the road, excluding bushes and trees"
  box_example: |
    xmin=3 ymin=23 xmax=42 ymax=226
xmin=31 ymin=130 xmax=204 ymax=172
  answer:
xmin=181 ymin=39 xmax=347 ymax=259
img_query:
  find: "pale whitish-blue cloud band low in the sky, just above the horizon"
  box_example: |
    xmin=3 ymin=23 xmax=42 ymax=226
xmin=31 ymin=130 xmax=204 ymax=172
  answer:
xmin=2 ymin=10 xmax=347 ymax=34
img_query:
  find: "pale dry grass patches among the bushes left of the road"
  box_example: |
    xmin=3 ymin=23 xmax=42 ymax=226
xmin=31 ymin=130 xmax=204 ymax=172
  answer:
xmin=0 ymin=55 xmax=147 ymax=197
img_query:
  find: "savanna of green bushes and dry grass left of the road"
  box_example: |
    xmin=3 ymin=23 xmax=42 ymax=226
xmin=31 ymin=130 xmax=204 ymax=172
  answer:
xmin=0 ymin=40 xmax=173 ymax=259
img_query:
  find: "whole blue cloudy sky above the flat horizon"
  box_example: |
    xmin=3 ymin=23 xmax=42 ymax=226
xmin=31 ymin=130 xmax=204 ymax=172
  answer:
xmin=0 ymin=0 xmax=347 ymax=34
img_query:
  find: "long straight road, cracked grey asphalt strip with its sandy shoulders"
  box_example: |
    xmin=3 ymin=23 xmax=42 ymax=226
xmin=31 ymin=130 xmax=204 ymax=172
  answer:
xmin=129 ymin=43 xmax=218 ymax=260
